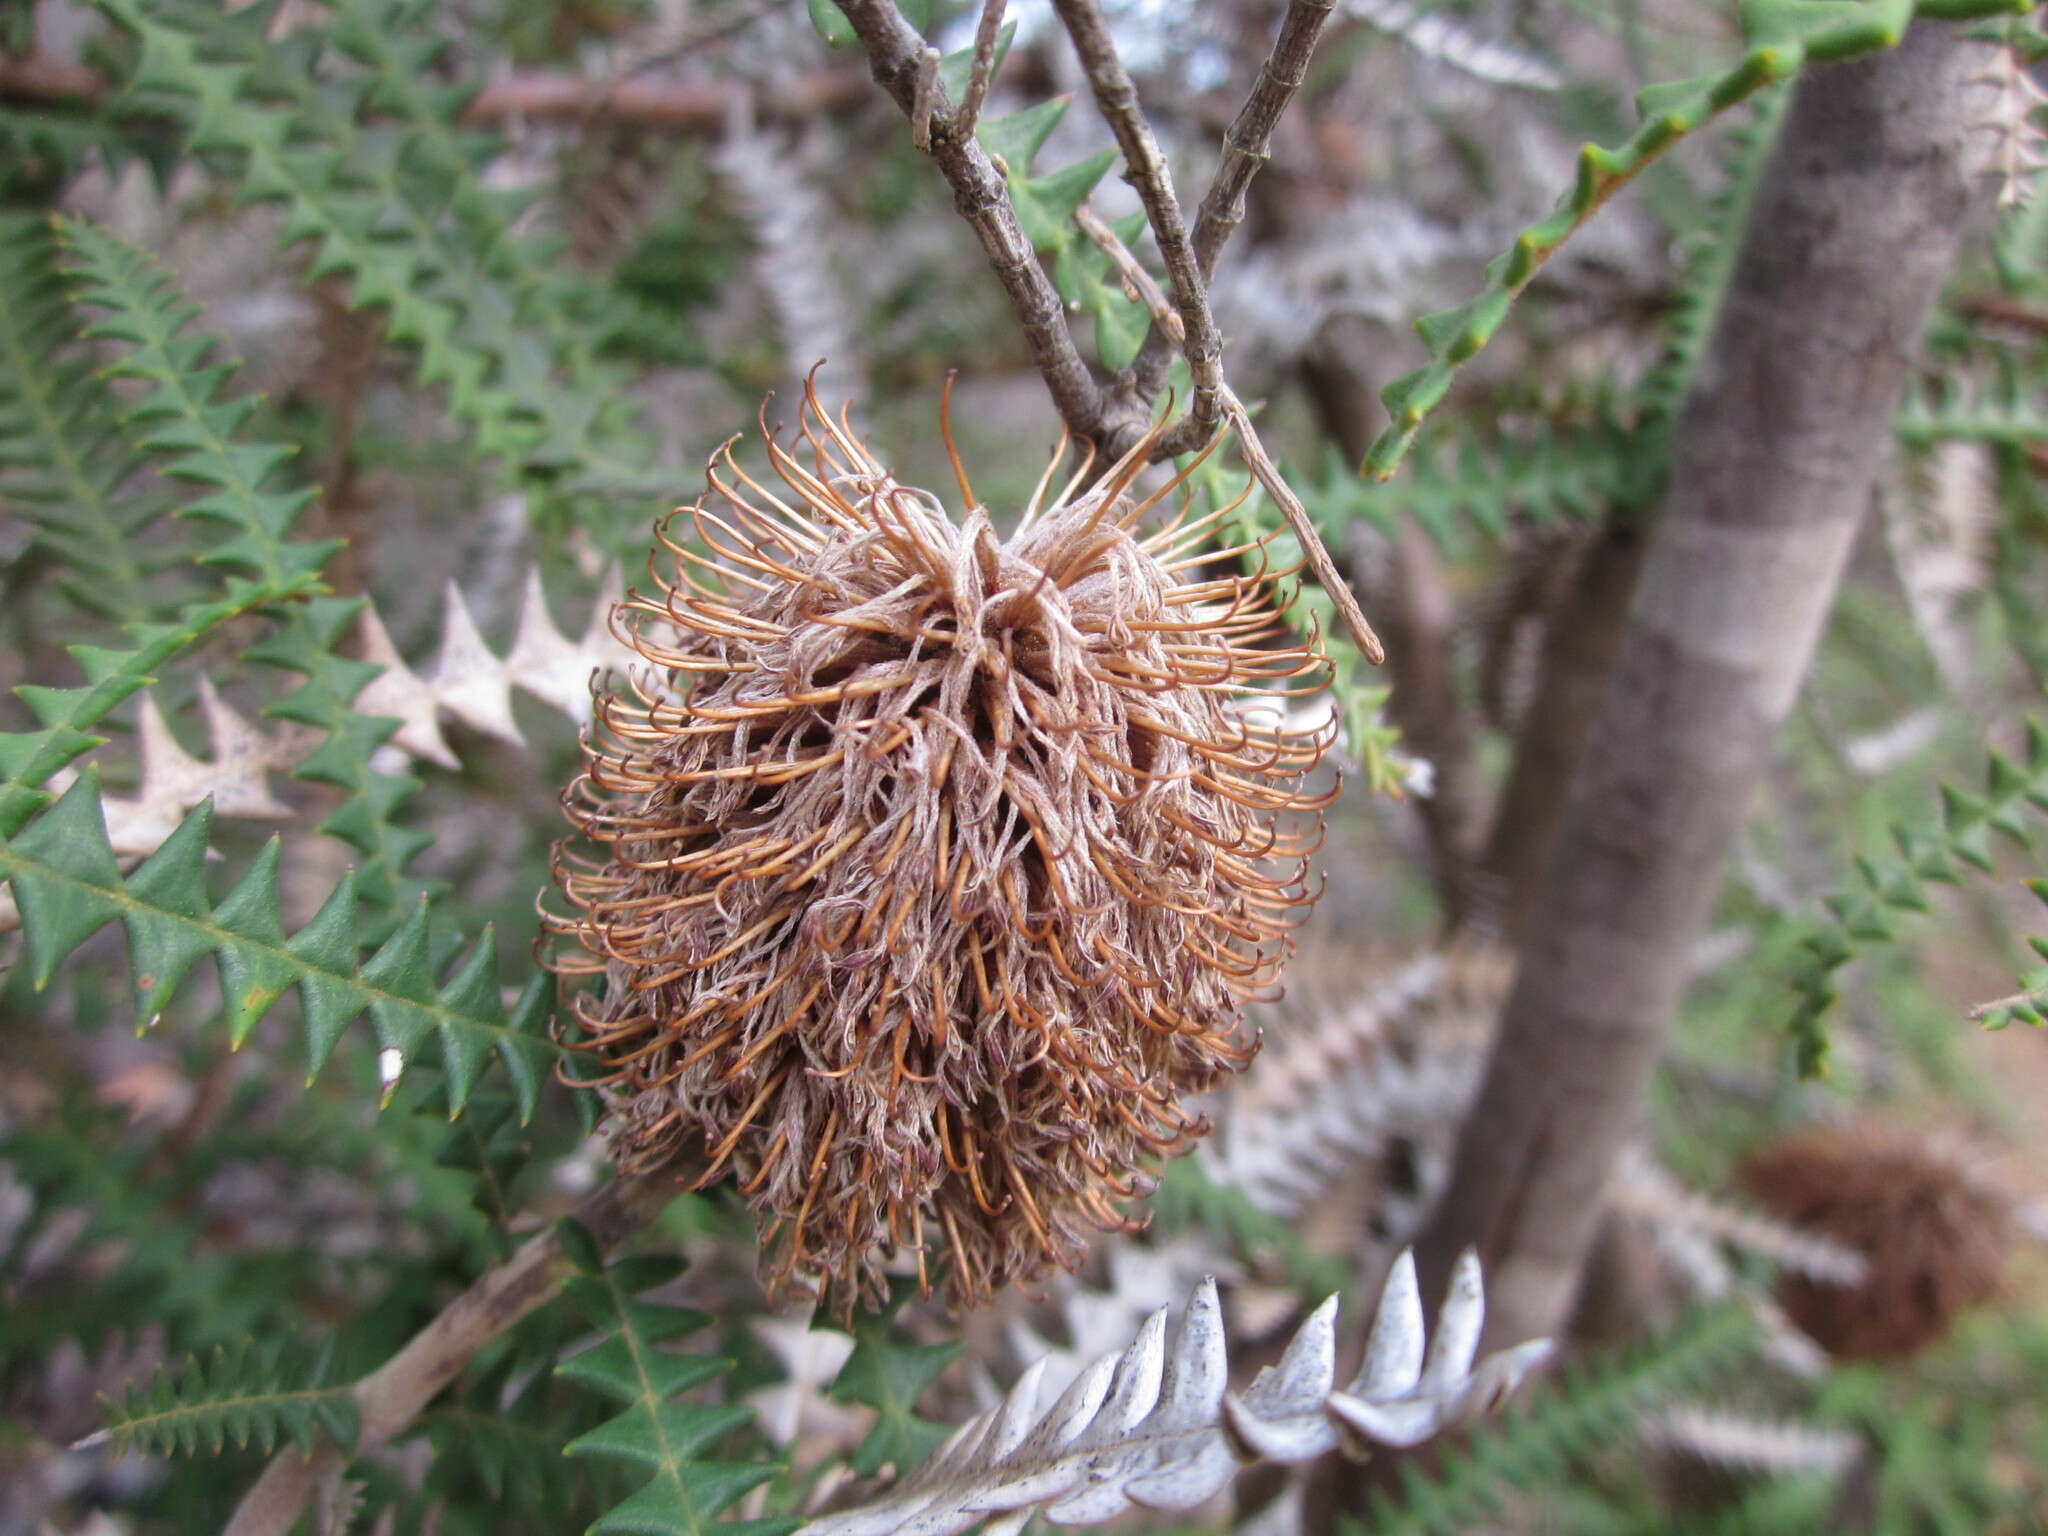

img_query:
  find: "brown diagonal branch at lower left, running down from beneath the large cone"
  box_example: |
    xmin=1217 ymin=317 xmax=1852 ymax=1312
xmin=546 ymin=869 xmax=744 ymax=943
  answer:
xmin=225 ymin=1171 xmax=676 ymax=1536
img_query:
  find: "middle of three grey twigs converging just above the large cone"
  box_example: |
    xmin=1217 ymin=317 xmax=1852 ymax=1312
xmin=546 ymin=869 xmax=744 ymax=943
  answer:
xmin=1053 ymin=0 xmax=1223 ymax=453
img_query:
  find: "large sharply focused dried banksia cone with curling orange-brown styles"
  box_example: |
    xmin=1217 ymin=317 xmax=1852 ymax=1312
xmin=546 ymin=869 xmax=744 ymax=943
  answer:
xmin=555 ymin=391 xmax=1335 ymax=1309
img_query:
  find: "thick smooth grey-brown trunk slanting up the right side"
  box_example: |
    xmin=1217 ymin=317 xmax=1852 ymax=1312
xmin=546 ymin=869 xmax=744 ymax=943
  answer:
xmin=1423 ymin=25 xmax=1987 ymax=1339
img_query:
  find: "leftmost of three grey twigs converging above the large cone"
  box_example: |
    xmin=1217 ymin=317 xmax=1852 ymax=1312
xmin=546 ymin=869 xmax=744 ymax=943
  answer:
xmin=836 ymin=0 xmax=1104 ymax=442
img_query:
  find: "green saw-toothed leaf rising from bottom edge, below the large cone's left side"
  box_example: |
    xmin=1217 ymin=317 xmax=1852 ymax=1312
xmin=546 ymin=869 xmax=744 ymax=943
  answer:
xmin=557 ymin=1223 xmax=801 ymax=1536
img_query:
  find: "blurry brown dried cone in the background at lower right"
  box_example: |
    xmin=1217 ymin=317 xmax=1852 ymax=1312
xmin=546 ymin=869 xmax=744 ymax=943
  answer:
xmin=1739 ymin=1124 xmax=2013 ymax=1360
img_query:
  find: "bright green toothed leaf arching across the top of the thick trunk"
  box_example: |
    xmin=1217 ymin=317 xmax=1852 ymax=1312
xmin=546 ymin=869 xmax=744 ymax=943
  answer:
xmin=1362 ymin=0 xmax=2025 ymax=479
